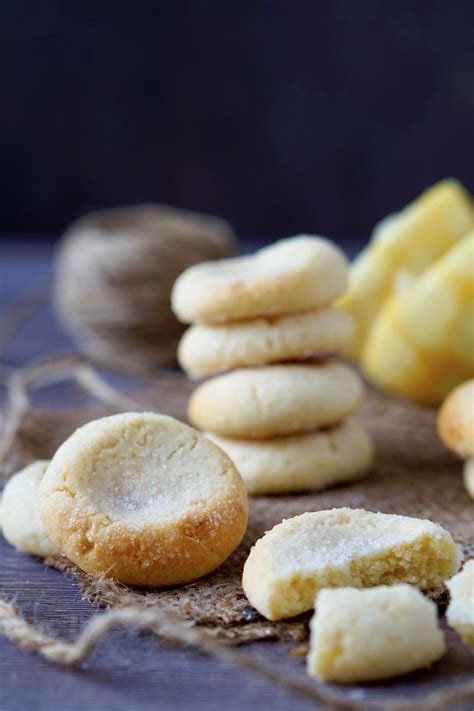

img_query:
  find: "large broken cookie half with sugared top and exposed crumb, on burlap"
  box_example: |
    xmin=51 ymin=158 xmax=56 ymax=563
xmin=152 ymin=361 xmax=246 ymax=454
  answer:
xmin=242 ymin=508 xmax=461 ymax=620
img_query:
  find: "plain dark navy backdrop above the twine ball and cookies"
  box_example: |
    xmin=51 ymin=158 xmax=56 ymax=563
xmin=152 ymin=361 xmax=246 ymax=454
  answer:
xmin=0 ymin=0 xmax=474 ymax=242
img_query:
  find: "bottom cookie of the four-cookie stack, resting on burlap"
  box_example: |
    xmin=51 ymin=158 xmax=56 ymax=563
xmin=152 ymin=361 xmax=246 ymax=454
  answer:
xmin=206 ymin=419 xmax=373 ymax=495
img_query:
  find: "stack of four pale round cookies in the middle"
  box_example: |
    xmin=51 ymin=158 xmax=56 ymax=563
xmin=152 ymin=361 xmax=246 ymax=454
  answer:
xmin=172 ymin=236 xmax=372 ymax=494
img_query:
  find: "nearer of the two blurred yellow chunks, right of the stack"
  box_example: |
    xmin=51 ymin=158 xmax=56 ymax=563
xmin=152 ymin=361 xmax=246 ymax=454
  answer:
xmin=362 ymin=230 xmax=474 ymax=405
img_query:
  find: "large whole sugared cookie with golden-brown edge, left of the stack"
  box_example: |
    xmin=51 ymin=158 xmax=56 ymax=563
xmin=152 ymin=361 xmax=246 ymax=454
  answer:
xmin=41 ymin=412 xmax=247 ymax=587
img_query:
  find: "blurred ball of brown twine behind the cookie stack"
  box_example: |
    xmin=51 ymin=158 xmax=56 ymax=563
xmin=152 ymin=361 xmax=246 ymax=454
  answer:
xmin=54 ymin=204 xmax=236 ymax=371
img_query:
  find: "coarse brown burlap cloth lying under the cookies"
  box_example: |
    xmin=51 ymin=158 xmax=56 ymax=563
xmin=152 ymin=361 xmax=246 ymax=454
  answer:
xmin=4 ymin=372 xmax=474 ymax=642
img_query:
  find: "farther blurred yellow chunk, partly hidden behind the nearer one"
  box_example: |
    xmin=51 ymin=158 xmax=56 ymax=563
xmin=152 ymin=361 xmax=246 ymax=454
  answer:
xmin=340 ymin=180 xmax=474 ymax=356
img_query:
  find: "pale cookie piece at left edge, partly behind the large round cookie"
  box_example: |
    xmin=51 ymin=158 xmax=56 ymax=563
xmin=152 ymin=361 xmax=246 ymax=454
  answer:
xmin=0 ymin=459 xmax=60 ymax=558
